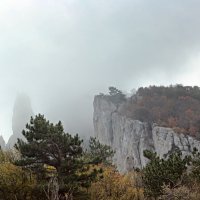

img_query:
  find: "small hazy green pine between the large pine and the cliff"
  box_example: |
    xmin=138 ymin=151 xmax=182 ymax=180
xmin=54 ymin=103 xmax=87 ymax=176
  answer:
xmin=88 ymin=137 xmax=114 ymax=164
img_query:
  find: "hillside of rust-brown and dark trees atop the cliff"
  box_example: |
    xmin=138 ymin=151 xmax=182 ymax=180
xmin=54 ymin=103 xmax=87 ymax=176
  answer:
xmin=119 ymin=85 xmax=200 ymax=139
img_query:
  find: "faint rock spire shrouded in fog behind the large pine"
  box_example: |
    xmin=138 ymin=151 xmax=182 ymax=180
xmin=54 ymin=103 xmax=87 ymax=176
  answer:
xmin=6 ymin=94 xmax=33 ymax=148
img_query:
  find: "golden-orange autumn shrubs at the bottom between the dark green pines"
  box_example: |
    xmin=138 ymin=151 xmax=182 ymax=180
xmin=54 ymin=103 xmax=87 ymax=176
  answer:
xmin=90 ymin=166 xmax=144 ymax=200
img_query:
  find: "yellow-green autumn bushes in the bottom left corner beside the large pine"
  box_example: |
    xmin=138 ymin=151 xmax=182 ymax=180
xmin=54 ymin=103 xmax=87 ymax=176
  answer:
xmin=0 ymin=151 xmax=36 ymax=200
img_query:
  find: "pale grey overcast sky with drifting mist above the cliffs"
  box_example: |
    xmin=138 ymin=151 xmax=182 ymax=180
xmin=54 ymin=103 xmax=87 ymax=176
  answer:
xmin=0 ymin=0 xmax=200 ymax=140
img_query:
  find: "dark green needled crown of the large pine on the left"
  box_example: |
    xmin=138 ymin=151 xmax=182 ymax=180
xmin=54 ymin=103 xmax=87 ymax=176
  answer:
xmin=15 ymin=115 xmax=82 ymax=171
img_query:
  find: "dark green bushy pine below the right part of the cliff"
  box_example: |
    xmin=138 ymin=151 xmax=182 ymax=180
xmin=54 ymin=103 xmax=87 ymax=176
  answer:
xmin=142 ymin=151 xmax=191 ymax=198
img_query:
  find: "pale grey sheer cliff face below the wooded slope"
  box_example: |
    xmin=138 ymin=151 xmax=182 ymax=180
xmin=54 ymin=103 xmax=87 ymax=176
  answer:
xmin=93 ymin=95 xmax=200 ymax=172
